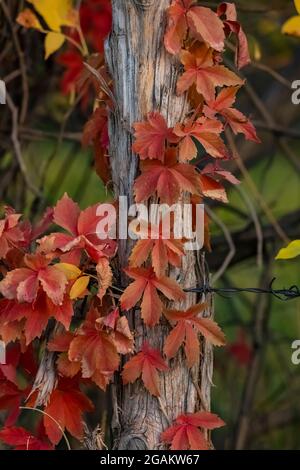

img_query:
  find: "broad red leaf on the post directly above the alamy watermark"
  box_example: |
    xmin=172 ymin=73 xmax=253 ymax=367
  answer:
xmin=134 ymin=149 xmax=199 ymax=205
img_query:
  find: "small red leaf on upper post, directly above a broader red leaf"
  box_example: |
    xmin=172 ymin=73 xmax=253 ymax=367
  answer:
xmin=132 ymin=112 xmax=174 ymax=160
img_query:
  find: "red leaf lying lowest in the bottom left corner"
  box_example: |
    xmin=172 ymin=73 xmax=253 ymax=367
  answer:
xmin=0 ymin=427 xmax=54 ymax=450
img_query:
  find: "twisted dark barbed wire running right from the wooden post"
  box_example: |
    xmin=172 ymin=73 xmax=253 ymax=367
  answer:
xmin=184 ymin=278 xmax=300 ymax=302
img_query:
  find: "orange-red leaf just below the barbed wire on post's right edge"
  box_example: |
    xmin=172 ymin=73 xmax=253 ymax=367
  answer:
xmin=164 ymin=304 xmax=225 ymax=367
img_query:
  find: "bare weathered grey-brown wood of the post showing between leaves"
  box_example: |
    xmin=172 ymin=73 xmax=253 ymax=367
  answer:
xmin=106 ymin=0 xmax=212 ymax=449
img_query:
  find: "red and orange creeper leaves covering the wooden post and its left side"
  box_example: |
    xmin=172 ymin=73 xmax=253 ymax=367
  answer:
xmin=0 ymin=0 xmax=259 ymax=449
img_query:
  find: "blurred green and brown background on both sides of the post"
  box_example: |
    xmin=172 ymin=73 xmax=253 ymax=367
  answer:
xmin=0 ymin=0 xmax=300 ymax=449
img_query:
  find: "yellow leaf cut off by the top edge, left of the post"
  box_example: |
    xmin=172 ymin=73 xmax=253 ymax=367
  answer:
xmin=28 ymin=0 xmax=75 ymax=31
